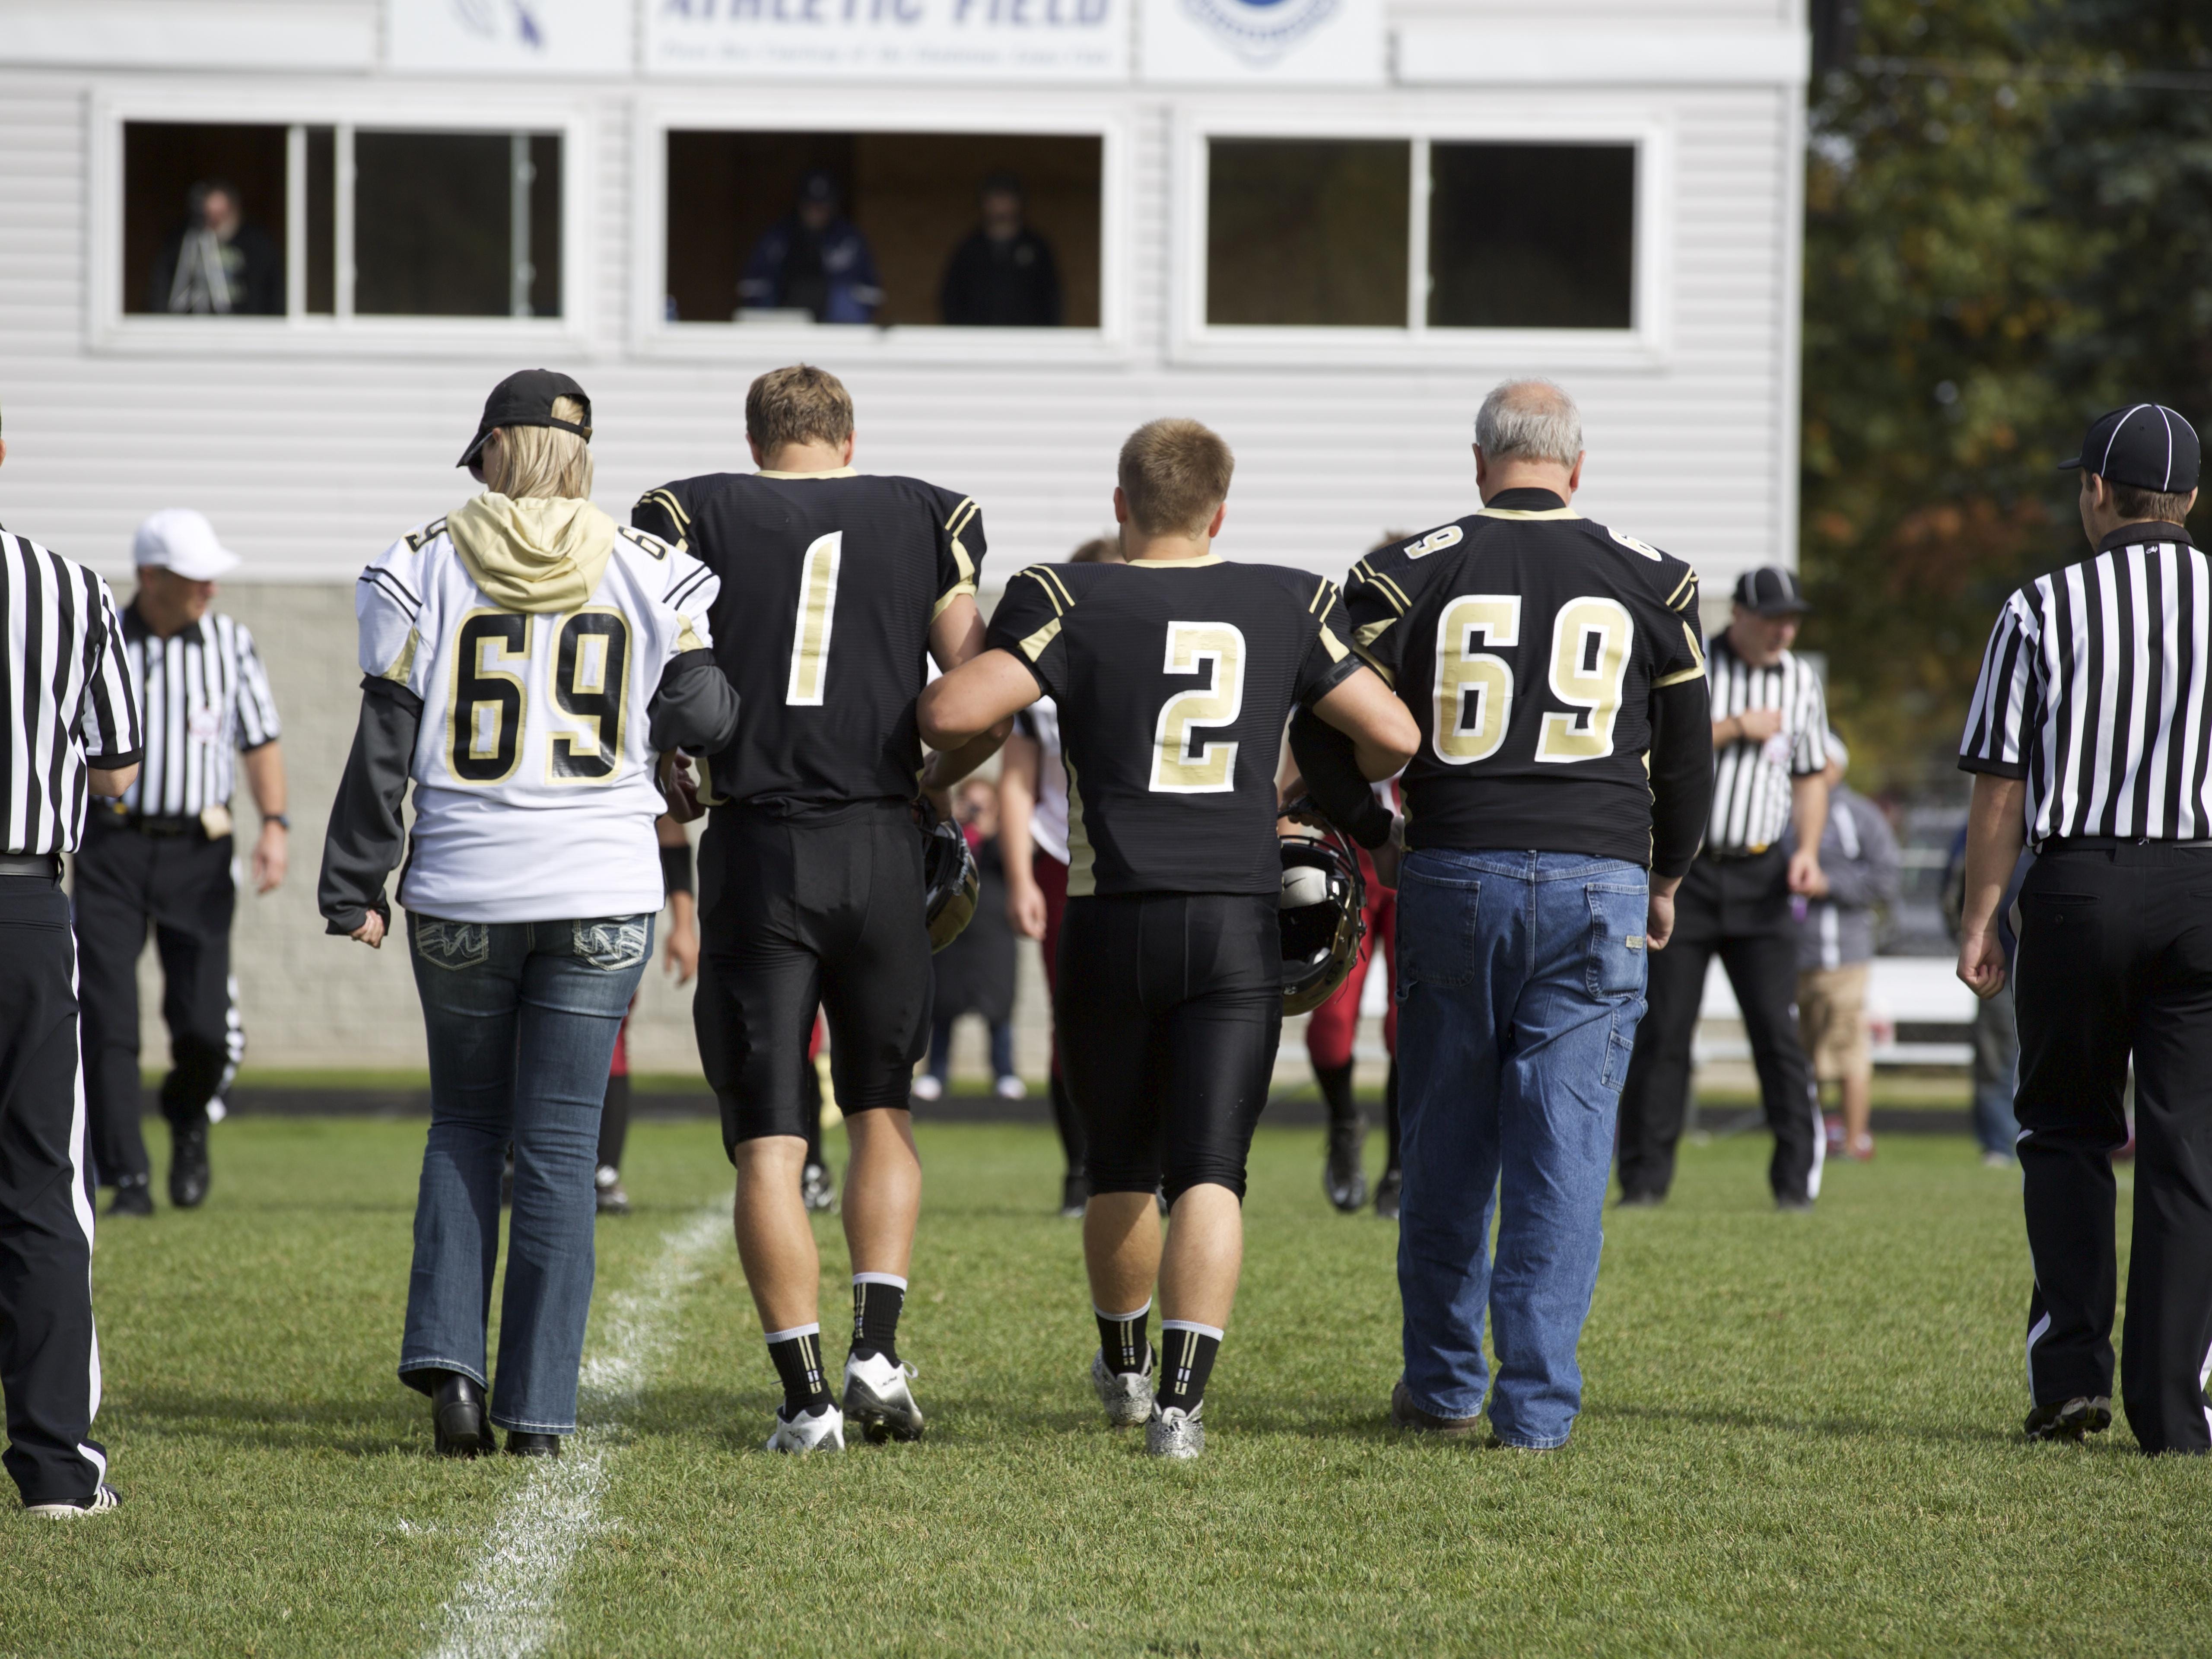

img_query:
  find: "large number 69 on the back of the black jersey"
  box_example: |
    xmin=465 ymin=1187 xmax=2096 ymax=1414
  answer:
xmin=1429 ymin=593 xmax=1635 ymax=766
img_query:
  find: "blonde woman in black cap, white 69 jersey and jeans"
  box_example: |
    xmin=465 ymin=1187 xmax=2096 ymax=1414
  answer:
xmin=318 ymin=369 xmax=737 ymax=1456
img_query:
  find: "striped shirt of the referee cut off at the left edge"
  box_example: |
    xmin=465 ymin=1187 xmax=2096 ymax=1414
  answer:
xmin=0 ymin=531 xmax=140 ymax=854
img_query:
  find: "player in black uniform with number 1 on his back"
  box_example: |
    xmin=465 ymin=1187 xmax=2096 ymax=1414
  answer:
xmin=630 ymin=365 xmax=1004 ymax=1451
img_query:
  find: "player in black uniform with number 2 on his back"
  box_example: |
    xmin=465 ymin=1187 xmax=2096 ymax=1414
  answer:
xmin=922 ymin=420 xmax=1416 ymax=1458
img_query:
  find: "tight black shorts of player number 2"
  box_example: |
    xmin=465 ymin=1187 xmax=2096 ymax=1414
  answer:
xmin=1053 ymin=893 xmax=1283 ymax=1203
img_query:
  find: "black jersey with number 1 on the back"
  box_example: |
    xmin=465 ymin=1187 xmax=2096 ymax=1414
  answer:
xmin=630 ymin=469 xmax=984 ymax=812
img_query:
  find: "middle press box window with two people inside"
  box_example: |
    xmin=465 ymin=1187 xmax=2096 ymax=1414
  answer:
xmin=666 ymin=130 xmax=1104 ymax=327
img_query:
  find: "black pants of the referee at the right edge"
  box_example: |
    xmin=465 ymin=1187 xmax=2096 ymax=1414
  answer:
xmin=2013 ymin=843 xmax=2212 ymax=1453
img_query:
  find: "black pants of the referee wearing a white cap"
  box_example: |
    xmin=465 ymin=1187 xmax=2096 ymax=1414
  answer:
xmin=75 ymin=810 xmax=237 ymax=1185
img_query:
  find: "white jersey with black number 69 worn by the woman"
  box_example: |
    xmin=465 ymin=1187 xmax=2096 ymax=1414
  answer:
xmin=354 ymin=520 xmax=721 ymax=922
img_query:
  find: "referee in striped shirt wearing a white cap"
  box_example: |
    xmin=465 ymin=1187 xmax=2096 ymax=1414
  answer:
xmin=75 ymin=509 xmax=288 ymax=1214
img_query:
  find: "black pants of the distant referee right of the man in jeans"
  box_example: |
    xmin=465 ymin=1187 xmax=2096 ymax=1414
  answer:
xmin=1619 ymin=847 xmax=1825 ymax=1201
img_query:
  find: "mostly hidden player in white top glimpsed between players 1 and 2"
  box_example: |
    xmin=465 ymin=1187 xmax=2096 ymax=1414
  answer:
xmin=998 ymin=535 xmax=1122 ymax=1221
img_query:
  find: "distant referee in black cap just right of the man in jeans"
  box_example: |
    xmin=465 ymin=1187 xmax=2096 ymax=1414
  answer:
xmin=1619 ymin=564 xmax=1827 ymax=1210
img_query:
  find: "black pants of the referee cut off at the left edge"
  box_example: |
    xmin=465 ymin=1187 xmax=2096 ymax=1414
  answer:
xmin=0 ymin=876 xmax=108 ymax=1504
